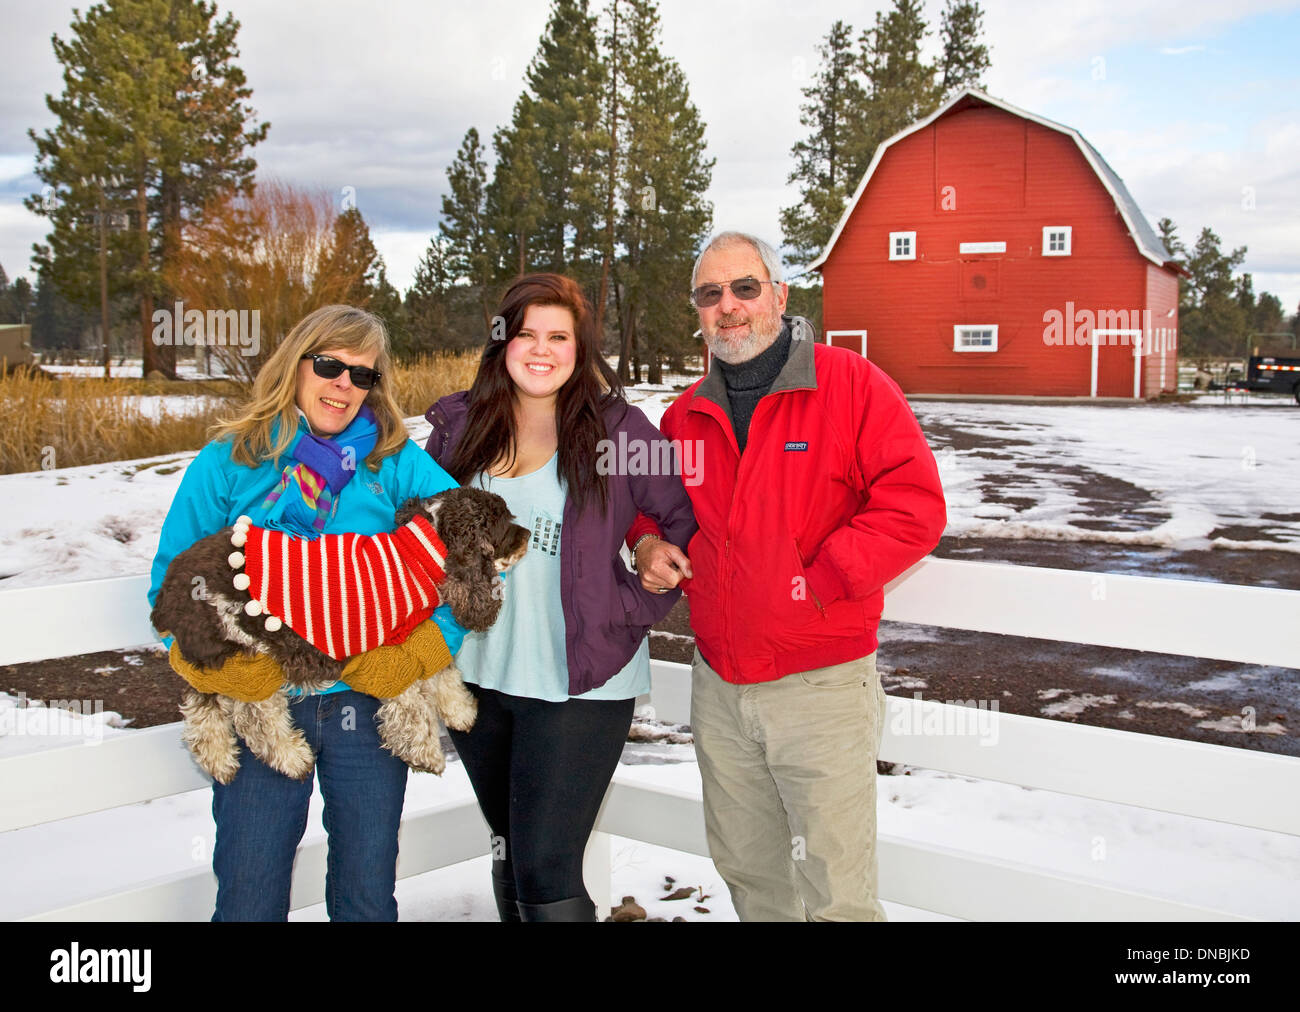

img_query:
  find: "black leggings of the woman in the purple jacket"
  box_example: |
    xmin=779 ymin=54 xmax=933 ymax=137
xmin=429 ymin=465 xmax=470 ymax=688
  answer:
xmin=449 ymin=684 xmax=636 ymax=904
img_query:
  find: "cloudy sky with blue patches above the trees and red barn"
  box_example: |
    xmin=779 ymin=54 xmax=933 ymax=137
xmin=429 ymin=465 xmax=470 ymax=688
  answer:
xmin=0 ymin=0 xmax=1300 ymax=312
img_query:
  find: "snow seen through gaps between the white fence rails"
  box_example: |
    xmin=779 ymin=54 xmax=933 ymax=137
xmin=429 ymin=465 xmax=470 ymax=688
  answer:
xmin=0 ymin=697 xmax=1300 ymax=921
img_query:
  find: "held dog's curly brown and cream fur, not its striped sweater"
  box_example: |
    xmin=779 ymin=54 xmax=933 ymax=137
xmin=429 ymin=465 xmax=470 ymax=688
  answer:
xmin=151 ymin=488 xmax=529 ymax=783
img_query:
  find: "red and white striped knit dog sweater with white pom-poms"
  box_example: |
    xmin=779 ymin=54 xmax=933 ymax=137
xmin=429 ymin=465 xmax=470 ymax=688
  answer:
xmin=230 ymin=516 xmax=447 ymax=661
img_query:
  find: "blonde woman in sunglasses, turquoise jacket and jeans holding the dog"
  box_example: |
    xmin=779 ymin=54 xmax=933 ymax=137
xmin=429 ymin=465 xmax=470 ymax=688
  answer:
xmin=150 ymin=306 xmax=455 ymax=921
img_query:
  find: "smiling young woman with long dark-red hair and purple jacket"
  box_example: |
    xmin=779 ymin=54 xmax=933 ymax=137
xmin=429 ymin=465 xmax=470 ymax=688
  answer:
xmin=426 ymin=274 xmax=696 ymax=921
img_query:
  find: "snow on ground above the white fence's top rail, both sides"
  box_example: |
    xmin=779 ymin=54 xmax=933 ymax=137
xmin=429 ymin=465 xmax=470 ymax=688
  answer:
xmin=0 ymin=386 xmax=1300 ymax=588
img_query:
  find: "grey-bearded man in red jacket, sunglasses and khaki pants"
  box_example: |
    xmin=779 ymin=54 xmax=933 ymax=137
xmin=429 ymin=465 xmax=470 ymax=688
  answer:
xmin=628 ymin=232 xmax=945 ymax=921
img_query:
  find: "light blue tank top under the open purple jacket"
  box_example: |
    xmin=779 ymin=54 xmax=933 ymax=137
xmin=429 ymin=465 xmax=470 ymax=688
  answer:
xmin=456 ymin=453 xmax=650 ymax=702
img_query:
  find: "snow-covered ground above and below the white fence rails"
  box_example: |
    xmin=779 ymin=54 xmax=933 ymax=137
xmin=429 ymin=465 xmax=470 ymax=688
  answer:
xmin=0 ymin=388 xmax=1300 ymax=920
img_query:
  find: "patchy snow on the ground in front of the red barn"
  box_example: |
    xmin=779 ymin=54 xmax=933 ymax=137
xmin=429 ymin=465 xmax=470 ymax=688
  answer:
xmin=911 ymin=401 xmax=1300 ymax=552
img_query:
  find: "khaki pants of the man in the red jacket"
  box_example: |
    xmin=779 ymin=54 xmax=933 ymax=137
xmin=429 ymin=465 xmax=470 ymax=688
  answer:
xmin=690 ymin=650 xmax=885 ymax=921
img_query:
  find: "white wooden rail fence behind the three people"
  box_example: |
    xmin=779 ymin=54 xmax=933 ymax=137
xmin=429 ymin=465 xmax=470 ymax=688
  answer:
xmin=0 ymin=559 xmax=1300 ymax=920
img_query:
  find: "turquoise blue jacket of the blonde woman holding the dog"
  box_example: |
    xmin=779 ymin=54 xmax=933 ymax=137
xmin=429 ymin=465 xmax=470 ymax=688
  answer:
xmin=150 ymin=418 xmax=464 ymax=692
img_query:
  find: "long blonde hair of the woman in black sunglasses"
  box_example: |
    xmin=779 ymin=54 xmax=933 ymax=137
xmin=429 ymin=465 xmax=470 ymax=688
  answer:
xmin=208 ymin=306 xmax=410 ymax=471
